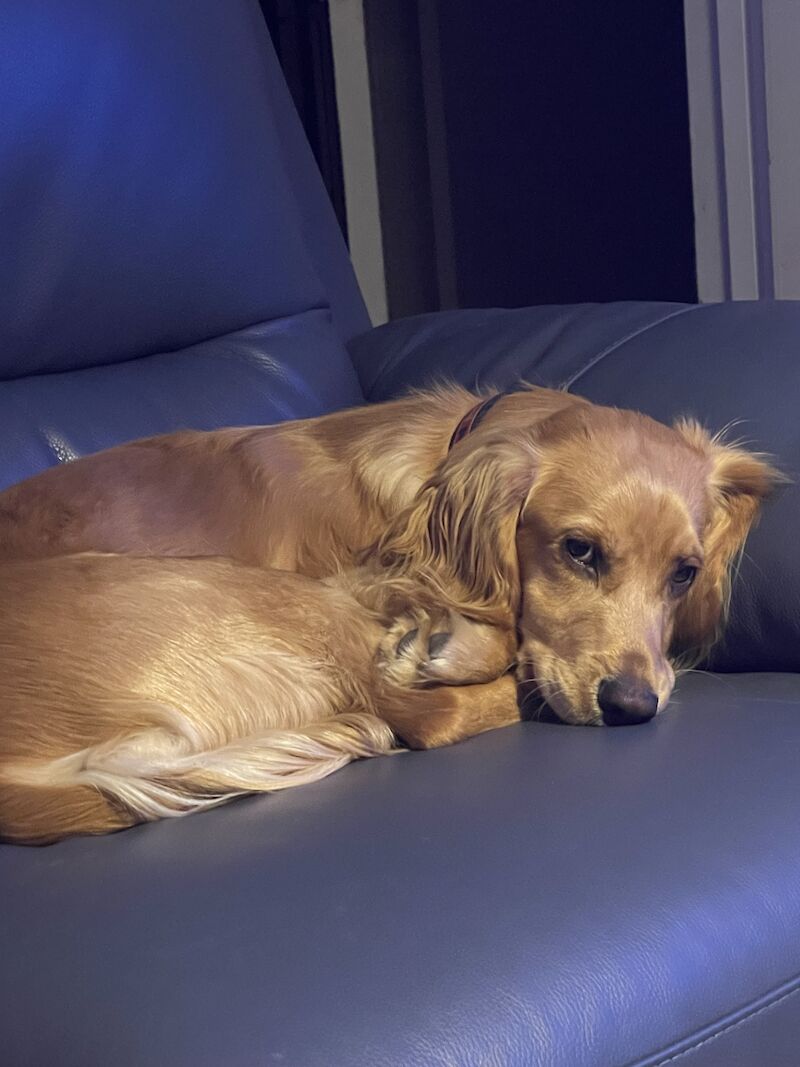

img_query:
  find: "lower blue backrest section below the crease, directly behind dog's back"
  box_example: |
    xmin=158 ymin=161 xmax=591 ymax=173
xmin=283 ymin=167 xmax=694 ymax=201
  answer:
xmin=0 ymin=309 xmax=363 ymax=487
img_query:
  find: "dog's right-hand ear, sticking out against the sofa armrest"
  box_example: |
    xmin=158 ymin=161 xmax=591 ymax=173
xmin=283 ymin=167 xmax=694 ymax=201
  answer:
xmin=673 ymin=419 xmax=787 ymax=663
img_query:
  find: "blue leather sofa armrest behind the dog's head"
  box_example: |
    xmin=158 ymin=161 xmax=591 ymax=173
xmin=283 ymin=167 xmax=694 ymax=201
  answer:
xmin=351 ymin=301 xmax=800 ymax=671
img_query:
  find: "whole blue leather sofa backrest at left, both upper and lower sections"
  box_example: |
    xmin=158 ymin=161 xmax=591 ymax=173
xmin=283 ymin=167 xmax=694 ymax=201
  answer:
xmin=0 ymin=0 xmax=369 ymax=484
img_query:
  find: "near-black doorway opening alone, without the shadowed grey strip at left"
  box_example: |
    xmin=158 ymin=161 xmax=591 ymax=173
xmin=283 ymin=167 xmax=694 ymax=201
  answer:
xmin=428 ymin=0 xmax=697 ymax=305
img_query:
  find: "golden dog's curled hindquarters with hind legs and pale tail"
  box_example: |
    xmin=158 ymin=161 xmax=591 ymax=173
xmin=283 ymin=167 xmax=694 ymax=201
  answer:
xmin=0 ymin=554 xmax=519 ymax=844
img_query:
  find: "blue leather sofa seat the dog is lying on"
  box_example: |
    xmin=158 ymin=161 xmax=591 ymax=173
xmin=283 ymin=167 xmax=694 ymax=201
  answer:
xmin=0 ymin=674 xmax=800 ymax=1067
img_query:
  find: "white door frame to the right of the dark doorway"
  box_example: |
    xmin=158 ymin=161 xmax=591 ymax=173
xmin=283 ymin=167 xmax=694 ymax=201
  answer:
xmin=684 ymin=0 xmax=800 ymax=302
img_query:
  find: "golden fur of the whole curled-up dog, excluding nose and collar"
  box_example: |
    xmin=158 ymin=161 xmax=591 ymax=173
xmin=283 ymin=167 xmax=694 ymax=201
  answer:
xmin=0 ymin=386 xmax=777 ymax=841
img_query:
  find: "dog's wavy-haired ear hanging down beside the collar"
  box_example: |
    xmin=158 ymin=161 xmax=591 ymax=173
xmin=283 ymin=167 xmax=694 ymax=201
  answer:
xmin=373 ymin=432 xmax=538 ymax=622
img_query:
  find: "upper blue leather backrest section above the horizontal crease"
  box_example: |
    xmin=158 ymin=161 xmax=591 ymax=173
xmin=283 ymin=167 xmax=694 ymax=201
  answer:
xmin=0 ymin=0 xmax=366 ymax=378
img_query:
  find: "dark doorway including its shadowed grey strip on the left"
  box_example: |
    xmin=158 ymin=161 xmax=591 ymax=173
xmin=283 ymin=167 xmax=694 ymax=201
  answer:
xmin=365 ymin=0 xmax=697 ymax=316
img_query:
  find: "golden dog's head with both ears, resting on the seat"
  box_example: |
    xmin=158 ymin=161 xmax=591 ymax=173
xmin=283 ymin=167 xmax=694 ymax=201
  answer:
xmin=380 ymin=403 xmax=779 ymax=724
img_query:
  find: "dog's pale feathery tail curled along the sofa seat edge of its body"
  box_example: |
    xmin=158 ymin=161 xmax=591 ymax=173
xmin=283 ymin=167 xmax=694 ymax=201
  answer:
xmin=0 ymin=712 xmax=397 ymax=844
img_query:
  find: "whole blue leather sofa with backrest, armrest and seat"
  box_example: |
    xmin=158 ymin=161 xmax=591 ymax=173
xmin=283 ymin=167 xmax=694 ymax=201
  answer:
xmin=0 ymin=0 xmax=800 ymax=1067
